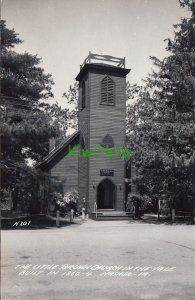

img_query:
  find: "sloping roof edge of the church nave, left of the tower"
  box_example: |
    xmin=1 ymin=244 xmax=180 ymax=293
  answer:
xmin=35 ymin=130 xmax=80 ymax=172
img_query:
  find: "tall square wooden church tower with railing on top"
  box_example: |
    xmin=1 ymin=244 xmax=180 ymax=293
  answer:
xmin=76 ymin=53 xmax=130 ymax=212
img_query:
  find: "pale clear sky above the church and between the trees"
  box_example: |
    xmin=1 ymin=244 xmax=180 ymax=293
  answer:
xmin=1 ymin=0 xmax=188 ymax=107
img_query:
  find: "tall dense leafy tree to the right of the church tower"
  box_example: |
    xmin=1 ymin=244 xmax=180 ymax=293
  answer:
xmin=127 ymin=0 xmax=195 ymax=211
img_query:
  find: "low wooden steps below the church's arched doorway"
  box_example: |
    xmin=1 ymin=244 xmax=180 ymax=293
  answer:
xmin=89 ymin=210 xmax=134 ymax=221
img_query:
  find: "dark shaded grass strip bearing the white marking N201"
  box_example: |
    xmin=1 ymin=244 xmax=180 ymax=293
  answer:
xmin=1 ymin=215 xmax=80 ymax=230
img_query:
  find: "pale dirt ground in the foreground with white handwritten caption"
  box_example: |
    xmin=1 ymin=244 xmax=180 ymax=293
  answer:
xmin=2 ymin=220 xmax=195 ymax=300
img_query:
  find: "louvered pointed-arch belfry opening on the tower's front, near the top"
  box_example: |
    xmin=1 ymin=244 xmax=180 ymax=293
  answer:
xmin=101 ymin=76 xmax=114 ymax=105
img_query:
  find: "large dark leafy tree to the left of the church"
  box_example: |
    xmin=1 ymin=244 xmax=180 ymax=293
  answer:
xmin=0 ymin=21 xmax=67 ymax=209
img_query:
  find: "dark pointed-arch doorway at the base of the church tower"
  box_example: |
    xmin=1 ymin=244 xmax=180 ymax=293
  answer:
xmin=97 ymin=178 xmax=116 ymax=209
